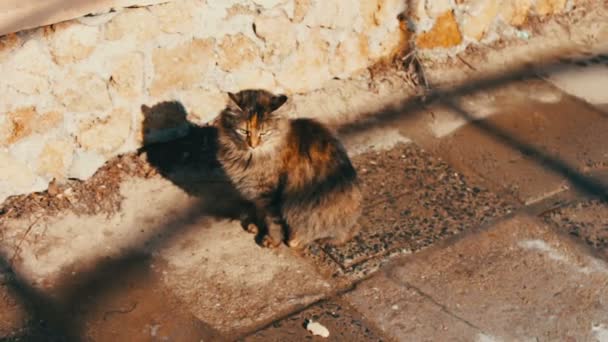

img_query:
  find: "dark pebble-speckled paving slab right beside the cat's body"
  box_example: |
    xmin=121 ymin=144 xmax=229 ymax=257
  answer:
xmin=322 ymin=144 xmax=513 ymax=274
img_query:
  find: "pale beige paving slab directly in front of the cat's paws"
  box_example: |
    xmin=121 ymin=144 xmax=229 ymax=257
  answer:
xmin=158 ymin=219 xmax=333 ymax=336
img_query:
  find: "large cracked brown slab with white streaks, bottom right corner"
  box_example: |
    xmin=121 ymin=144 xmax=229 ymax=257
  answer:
xmin=345 ymin=216 xmax=608 ymax=341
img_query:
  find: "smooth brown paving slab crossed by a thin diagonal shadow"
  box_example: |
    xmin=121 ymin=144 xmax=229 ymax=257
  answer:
xmin=436 ymin=87 xmax=608 ymax=204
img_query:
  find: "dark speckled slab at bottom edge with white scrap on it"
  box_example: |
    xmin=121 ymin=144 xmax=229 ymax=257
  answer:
xmin=243 ymin=300 xmax=386 ymax=342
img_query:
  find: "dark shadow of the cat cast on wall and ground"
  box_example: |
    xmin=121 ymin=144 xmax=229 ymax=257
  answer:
xmin=139 ymin=101 xmax=262 ymax=243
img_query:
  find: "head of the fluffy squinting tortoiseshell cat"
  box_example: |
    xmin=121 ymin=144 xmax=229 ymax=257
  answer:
xmin=219 ymin=89 xmax=287 ymax=149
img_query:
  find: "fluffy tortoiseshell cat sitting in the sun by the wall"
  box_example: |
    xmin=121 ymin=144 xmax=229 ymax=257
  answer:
xmin=214 ymin=89 xmax=362 ymax=250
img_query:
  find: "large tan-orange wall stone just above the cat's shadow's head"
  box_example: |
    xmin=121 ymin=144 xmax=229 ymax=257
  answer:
xmin=150 ymin=39 xmax=216 ymax=96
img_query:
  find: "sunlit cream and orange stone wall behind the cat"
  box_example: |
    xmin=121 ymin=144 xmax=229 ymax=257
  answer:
xmin=0 ymin=0 xmax=580 ymax=202
